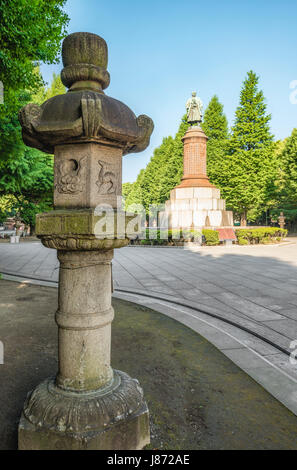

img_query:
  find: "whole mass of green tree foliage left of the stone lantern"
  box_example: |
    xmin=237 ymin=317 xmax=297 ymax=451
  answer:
xmin=0 ymin=0 xmax=68 ymax=230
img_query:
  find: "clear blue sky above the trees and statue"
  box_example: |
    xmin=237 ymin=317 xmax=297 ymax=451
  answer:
xmin=41 ymin=0 xmax=297 ymax=182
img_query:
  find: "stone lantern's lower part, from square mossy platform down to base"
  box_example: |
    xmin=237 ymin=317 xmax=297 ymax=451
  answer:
xmin=19 ymin=210 xmax=150 ymax=450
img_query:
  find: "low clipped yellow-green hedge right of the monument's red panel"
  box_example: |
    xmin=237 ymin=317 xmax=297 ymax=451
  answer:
xmin=235 ymin=227 xmax=288 ymax=245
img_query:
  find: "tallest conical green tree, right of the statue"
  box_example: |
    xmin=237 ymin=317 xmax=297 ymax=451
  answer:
xmin=222 ymin=71 xmax=276 ymax=225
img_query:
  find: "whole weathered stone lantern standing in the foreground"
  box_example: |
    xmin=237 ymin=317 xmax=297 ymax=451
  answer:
xmin=19 ymin=33 xmax=153 ymax=450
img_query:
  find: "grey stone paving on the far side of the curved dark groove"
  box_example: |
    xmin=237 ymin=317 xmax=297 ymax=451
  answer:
xmin=0 ymin=240 xmax=297 ymax=351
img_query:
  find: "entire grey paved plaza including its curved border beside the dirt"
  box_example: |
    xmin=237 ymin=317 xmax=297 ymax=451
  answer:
xmin=0 ymin=239 xmax=297 ymax=414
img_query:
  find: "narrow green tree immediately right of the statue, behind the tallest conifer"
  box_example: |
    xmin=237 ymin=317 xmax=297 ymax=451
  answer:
xmin=201 ymin=95 xmax=229 ymax=187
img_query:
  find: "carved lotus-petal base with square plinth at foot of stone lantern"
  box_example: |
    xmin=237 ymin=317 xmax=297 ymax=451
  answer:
xmin=18 ymin=371 xmax=150 ymax=450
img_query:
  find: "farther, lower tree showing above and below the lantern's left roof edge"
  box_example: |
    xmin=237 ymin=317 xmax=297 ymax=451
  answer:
xmin=0 ymin=71 xmax=66 ymax=229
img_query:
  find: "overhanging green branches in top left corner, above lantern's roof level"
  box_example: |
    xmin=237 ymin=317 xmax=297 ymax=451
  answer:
xmin=0 ymin=0 xmax=69 ymax=92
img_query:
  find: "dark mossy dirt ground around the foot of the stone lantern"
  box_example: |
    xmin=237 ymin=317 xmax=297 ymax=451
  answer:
xmin=0 ymin=280 xmax=297 ymax=449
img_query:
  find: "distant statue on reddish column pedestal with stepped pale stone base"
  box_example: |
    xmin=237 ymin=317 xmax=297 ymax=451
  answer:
xmin=160 ymin=92 xmax=233 ymax=231
